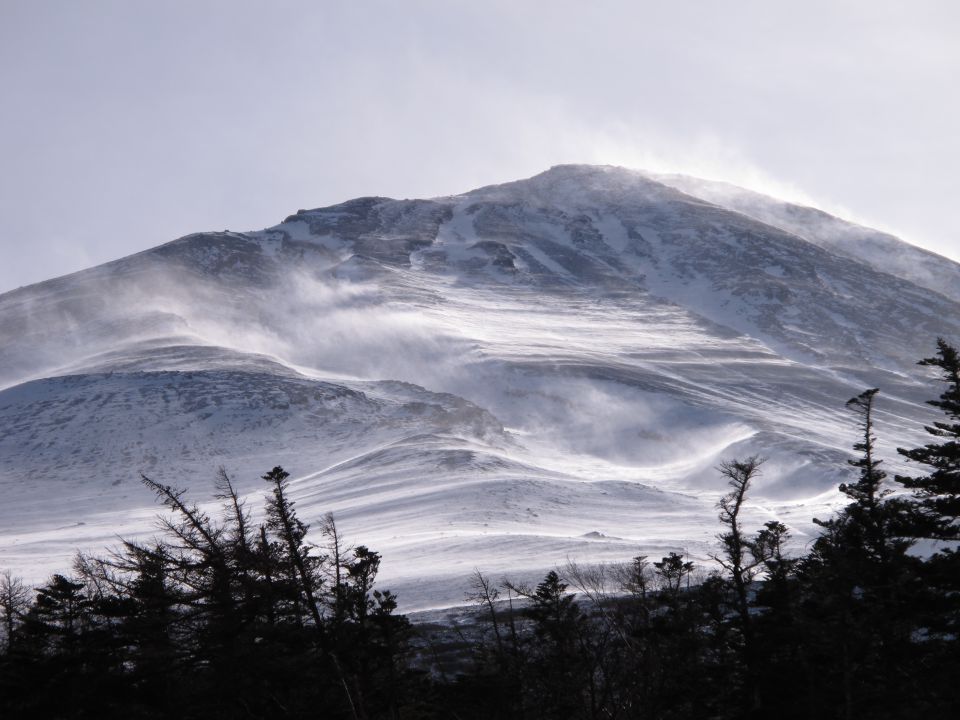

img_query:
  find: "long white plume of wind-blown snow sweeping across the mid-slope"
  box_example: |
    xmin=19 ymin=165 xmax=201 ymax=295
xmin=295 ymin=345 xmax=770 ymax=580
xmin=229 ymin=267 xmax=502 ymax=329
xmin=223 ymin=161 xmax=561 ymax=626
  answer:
xmin=1 ymin=258 xmax=753 ymax=496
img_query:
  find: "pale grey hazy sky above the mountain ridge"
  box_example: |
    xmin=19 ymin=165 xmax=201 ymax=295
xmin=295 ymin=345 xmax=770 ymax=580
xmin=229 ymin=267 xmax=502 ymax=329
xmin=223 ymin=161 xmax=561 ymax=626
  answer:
xmin=0 ymin=0 xmax=960 ymax=292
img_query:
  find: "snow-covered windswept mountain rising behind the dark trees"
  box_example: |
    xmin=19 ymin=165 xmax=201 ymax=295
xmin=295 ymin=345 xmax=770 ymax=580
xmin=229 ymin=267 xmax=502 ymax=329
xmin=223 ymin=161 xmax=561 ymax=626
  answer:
xmin=0 ymin=166 xmax=960 ymax=608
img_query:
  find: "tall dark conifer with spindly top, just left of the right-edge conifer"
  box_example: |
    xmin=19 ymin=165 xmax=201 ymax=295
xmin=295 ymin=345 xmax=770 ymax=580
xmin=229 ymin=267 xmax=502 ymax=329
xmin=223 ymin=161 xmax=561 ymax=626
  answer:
xmin=800 ymin=388 xmax=918 ymax=717
